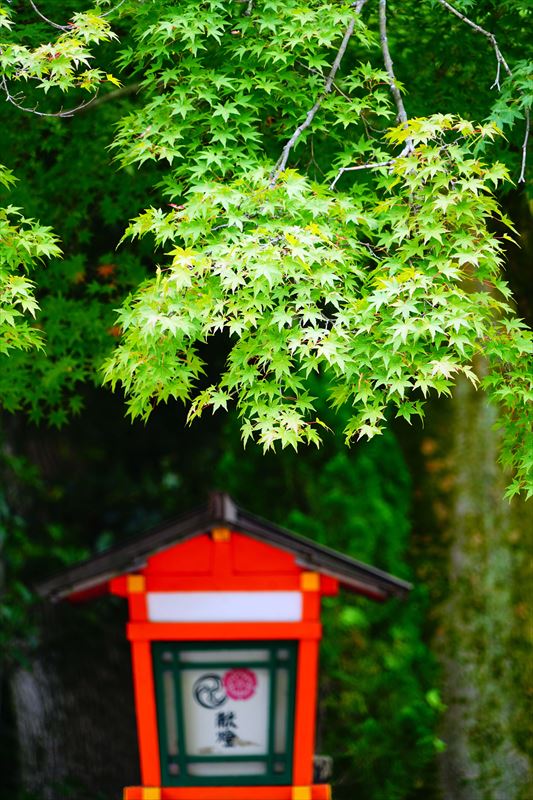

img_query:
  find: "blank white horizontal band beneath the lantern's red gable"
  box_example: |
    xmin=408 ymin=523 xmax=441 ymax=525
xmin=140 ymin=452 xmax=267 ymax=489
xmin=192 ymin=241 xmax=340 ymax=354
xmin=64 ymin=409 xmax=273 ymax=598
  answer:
xmin=147 ymin=592 xmax=302 ymax=622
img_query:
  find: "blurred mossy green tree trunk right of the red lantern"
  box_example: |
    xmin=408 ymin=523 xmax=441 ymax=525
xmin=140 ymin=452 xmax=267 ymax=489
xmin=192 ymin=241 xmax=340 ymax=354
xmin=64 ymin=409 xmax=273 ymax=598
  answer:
xmin=410 ymin=382 xmax=533 ymax=800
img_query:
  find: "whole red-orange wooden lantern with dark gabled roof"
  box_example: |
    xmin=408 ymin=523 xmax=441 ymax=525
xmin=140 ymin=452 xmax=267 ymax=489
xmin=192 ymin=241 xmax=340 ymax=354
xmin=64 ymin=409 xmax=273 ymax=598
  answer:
xmin=39 ymin=493 xmax=410 ymax=800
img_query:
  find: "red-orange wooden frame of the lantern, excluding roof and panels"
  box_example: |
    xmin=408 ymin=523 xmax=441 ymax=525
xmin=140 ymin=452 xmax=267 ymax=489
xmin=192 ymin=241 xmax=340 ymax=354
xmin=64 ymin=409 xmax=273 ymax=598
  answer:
xmin=110 ymin=528 xmax=330 ymax=800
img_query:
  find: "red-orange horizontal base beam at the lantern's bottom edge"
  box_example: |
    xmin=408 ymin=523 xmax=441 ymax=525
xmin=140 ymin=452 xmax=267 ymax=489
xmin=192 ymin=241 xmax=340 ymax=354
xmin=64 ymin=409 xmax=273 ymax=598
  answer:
xmin=123 ymin=783 xmax=331 ymax=800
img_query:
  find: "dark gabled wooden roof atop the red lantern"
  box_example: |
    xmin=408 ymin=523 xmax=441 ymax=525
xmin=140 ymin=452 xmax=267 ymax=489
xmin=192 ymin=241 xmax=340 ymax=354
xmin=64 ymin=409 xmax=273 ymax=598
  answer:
xmin=36 ymin=492 xmax=412 ymax=600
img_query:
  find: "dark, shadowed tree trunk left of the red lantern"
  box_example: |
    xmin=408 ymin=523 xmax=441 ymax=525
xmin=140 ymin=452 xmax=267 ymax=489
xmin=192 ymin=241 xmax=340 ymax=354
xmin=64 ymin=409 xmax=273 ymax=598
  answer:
xmin=10 ymin=600 xmax=139 ymax=800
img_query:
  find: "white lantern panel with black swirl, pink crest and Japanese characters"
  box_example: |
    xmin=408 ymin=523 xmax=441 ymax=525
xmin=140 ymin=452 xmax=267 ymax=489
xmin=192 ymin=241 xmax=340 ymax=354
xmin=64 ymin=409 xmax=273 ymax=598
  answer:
xmin=181 ymin=667 xmax=270 ymax=758
